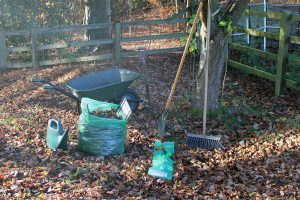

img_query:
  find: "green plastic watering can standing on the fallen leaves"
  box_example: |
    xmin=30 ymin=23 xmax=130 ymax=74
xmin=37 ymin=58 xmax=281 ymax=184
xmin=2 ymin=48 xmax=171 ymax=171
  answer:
xmin=47 ymin=119 xmax=69 ymax=150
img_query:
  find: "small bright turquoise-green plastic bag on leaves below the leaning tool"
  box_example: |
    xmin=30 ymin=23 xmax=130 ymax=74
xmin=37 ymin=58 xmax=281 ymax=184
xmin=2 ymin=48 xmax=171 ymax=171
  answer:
xmin=148 ymin=141 xmax=175 ymax=180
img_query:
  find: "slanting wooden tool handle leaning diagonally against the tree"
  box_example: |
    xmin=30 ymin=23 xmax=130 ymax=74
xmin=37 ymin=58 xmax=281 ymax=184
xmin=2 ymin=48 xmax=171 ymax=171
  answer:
xmin=165 ymin=5 xmax=201 ymax=110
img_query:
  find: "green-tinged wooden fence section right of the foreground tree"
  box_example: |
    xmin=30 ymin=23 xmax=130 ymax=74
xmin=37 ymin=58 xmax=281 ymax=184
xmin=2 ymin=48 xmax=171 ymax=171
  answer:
xmin=229 ymin=10 xmax=300 ymax=96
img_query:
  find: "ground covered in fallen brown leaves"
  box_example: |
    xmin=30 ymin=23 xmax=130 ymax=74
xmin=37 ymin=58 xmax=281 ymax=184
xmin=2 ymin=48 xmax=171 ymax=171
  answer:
xmin=0 ymin=54 xmax=300 ymax=200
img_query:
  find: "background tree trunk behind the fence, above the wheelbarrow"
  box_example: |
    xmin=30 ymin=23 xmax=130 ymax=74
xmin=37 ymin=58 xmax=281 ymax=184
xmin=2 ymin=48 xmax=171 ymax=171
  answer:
xmin=83 ymin=0 xmax=111 ymax=40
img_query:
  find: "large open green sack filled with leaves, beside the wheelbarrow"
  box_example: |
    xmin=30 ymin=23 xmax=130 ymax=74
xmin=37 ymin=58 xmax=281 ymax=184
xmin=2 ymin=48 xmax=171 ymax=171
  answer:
xmin=78 ymin=98 xmax=127 ymax=156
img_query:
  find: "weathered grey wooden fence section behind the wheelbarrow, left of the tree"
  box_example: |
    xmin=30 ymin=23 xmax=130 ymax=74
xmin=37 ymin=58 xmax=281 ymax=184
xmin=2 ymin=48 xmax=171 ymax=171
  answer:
xmin=0 ymin=16 xmax=186 ymax=69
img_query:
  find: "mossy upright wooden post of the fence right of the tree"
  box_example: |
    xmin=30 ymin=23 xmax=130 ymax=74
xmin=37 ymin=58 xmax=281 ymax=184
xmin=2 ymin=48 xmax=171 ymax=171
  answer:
xmin=275 ymin=15 xmax=291 ymax=96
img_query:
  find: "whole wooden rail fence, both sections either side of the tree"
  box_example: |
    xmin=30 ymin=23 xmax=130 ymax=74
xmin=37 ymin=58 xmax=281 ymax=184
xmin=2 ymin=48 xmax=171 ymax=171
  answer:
xmin=0 ymin=10 xmax=300 ymax=95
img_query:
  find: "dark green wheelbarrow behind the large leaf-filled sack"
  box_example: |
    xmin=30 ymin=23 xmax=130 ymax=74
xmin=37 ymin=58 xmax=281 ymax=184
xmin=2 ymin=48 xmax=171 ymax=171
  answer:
xmin=31 ymin=68 xmax=141 ymax=113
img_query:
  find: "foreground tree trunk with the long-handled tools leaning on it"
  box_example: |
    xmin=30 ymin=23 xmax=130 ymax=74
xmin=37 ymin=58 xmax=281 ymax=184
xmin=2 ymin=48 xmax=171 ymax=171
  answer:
xmin=194 ymin=0 xmax=249 ymax=110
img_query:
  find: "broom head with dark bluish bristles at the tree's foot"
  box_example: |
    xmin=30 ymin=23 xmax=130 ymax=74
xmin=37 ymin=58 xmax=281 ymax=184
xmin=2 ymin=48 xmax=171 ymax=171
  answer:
xmin=186 ymin=134 xmax=223 ymax=150
